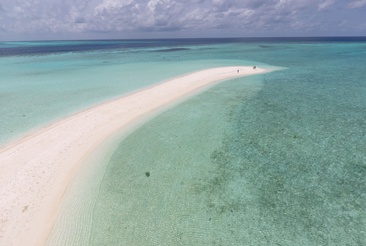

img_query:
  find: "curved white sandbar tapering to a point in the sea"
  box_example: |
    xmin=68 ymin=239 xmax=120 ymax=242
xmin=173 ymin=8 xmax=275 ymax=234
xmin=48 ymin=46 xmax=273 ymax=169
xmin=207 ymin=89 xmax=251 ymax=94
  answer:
xmin=0 ymin=67 xmax=266 ymax=246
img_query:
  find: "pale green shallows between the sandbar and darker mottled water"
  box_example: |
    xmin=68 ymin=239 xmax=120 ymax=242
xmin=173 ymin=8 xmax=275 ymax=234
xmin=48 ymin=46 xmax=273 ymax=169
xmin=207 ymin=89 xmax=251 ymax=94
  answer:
xmin=49 ymin=73 xmax=262 ymax=245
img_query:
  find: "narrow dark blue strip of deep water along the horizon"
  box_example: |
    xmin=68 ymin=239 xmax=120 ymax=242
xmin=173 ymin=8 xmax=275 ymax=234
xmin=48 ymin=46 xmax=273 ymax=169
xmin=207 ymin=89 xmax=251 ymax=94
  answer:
xmin=0 ymin=37 xmax=366 ymax=57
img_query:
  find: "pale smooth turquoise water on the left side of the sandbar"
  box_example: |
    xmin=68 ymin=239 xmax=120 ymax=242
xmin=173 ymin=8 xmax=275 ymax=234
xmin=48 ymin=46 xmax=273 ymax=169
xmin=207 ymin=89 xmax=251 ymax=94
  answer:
xmin=0 ymin=45 xmax=258 ymax=146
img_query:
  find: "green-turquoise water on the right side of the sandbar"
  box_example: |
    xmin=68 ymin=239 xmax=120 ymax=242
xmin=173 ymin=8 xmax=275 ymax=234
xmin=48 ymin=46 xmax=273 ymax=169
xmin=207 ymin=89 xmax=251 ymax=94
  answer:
xmin=83 ymin=40 xmax=366 ymax=245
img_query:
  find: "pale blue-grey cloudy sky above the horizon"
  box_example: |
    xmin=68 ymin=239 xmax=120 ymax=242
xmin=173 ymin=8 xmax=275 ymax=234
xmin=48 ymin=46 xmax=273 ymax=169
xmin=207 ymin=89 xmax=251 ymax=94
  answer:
xmin=0 ymin=0 xmax=366 ymax=40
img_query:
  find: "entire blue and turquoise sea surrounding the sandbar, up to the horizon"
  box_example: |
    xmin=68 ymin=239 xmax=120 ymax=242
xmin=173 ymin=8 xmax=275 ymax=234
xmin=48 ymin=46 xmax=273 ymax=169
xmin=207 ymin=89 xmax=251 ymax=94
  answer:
xmin=0 ymin=37 xmax=366 ymax=246
